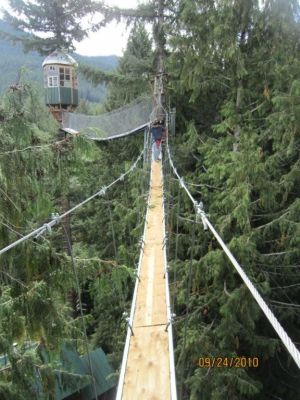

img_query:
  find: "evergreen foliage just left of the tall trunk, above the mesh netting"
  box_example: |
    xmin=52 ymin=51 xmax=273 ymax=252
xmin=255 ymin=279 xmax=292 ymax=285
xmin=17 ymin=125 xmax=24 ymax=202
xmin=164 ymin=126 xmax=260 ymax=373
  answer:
xmin=80 ymin=0 xmax=174 ymax=101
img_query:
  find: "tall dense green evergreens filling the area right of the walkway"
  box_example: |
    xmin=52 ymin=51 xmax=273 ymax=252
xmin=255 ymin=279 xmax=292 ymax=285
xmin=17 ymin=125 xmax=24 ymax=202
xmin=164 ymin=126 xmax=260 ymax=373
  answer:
xmin=168 ymin=0 xmax=300 ymax=399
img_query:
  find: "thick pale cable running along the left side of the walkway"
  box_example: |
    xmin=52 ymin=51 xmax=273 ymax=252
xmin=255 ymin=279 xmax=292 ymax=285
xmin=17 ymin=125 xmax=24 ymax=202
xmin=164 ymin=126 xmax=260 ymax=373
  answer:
xmin=0 ymin=150 xmax=144 ymax=255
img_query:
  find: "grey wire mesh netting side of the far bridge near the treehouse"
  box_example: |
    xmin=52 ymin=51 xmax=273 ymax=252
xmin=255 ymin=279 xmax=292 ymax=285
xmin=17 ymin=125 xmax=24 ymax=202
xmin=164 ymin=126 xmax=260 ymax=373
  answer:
xmin=62 ymin=97 xmax=152 ymax=140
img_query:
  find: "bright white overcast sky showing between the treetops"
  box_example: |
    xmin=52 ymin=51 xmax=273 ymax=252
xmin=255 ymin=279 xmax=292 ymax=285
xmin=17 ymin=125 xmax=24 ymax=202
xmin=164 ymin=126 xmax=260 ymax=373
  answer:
xmin=0 ymin=0 xmax=146 ymax=56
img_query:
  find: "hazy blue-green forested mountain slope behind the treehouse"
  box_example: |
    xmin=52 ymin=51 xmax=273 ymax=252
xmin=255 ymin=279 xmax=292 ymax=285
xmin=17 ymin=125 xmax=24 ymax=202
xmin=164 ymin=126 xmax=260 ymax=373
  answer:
xmin=0 ymin=20 xmax=118 ymax=102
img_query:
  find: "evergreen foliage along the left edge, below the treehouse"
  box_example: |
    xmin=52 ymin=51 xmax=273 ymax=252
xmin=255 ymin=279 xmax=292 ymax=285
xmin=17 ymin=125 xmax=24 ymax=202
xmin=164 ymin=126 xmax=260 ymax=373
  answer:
xmin=0 ymin=83 xmax=80 ymax=399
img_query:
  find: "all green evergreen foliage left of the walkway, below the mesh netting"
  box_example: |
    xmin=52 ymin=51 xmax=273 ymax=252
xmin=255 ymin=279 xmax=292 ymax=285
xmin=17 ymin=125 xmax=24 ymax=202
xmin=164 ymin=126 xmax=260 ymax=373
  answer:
xmin=0 ymin=80 xmax=145 ymax=399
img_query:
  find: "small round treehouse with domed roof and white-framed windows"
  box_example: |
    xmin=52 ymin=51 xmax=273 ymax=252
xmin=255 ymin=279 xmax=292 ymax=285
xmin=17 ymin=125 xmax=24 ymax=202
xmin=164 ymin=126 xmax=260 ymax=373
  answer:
xmin=43 ymin=50 xmax=78 ymax=111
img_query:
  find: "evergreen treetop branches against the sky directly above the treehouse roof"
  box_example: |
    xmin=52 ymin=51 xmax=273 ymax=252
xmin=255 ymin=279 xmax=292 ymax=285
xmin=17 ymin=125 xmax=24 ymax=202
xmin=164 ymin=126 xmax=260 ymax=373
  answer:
xmin=2 ymin=0 xmax=94 ymax=55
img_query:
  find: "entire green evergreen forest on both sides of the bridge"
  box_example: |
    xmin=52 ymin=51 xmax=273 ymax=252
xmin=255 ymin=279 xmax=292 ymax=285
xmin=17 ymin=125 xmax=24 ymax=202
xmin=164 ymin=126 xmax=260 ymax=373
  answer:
xmin=0 ymin=0 xmax=300 ymax=400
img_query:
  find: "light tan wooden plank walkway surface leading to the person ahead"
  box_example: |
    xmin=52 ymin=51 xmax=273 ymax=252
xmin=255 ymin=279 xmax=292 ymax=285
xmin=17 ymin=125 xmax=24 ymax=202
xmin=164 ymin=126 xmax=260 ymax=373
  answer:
xmin=122 ymin=162 xmax=172 ymax=400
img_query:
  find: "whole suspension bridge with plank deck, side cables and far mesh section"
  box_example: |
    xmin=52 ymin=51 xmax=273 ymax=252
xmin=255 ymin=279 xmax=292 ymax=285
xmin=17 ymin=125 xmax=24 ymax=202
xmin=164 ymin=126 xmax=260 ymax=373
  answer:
xmin=0 ymin=98 xmax=300 ymax=400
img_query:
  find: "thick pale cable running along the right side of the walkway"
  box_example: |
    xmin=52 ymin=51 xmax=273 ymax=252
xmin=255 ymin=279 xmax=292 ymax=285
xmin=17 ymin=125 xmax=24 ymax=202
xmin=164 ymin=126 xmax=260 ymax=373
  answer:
xmin=167 ymin=140 xmax=300 ymax=368
